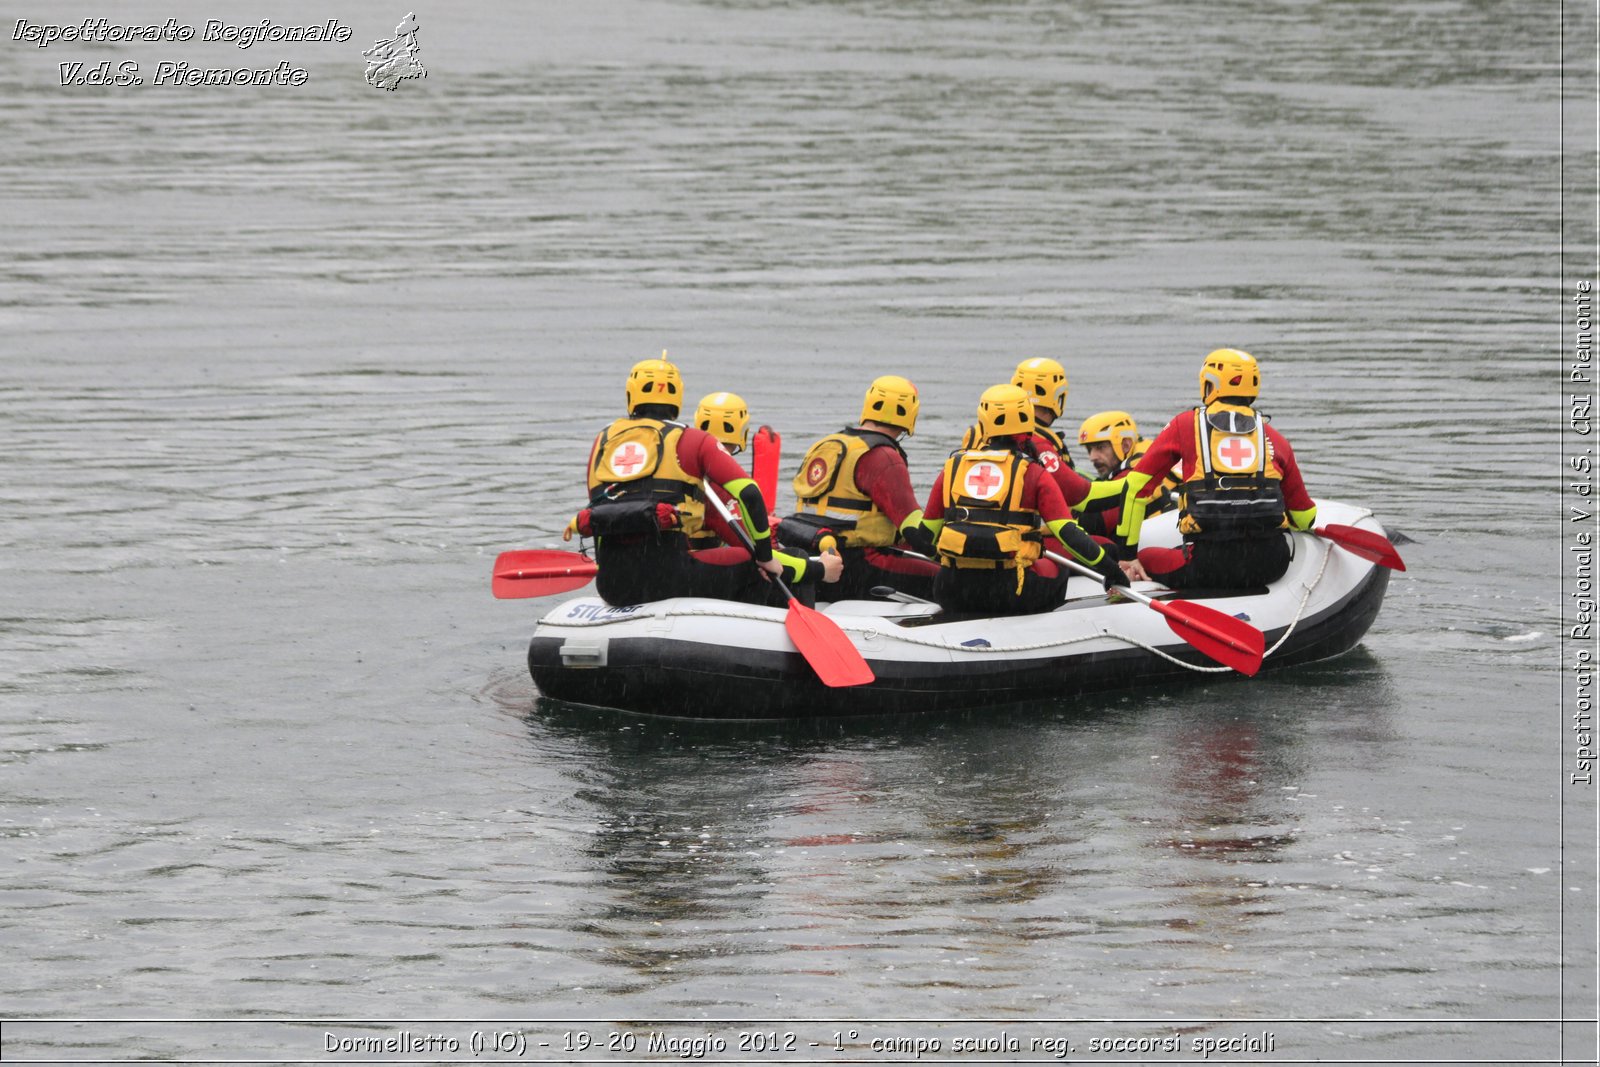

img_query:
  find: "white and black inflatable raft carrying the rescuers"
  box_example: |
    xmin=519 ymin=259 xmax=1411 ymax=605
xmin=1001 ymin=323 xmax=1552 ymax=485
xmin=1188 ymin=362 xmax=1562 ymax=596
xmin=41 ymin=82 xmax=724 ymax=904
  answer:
xmin=528 ymin=501 xmax=1405 ymax=718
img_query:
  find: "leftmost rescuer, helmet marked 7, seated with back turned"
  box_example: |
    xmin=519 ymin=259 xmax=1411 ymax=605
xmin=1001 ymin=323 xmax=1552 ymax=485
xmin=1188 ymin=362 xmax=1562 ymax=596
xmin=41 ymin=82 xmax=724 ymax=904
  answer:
xmin=562 ymin=352 xmax=826 ymax=606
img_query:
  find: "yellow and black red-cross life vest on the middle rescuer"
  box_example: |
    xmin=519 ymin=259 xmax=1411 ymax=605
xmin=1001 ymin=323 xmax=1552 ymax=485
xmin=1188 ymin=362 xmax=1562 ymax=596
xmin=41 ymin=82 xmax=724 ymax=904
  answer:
xmin=936 ymin=450 xmax=1043 ymax=581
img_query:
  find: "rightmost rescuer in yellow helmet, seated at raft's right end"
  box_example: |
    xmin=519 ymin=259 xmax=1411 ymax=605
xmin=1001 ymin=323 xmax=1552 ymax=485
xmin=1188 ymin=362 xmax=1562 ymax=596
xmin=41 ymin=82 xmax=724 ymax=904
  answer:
xmin=1117 ymin=349 xmax=1317 ymax=589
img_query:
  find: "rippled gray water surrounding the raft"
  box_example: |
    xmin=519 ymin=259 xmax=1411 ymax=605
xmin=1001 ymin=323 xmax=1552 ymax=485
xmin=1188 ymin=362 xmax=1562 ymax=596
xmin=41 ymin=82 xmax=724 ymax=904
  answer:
xmin=0 ymin=0 xmax=1597 ymax=1062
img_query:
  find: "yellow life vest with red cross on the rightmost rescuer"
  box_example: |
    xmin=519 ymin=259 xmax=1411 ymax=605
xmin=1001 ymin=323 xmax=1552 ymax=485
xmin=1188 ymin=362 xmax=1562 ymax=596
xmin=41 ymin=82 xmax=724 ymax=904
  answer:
xmin=1178 ymin=405 xmax=1290 ymax=539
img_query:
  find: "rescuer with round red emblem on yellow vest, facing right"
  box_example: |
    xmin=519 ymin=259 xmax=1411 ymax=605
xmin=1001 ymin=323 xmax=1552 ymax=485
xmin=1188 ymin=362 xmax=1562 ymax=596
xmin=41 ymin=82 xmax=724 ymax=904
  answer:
xmin=778 ymin=374 xmax=939 ymax=600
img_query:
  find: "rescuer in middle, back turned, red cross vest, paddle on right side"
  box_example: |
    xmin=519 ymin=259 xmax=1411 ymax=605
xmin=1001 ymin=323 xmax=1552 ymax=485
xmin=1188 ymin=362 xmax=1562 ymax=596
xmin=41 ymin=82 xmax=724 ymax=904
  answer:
xmin=922 ymin=386 xmax=1128 ymax=616
